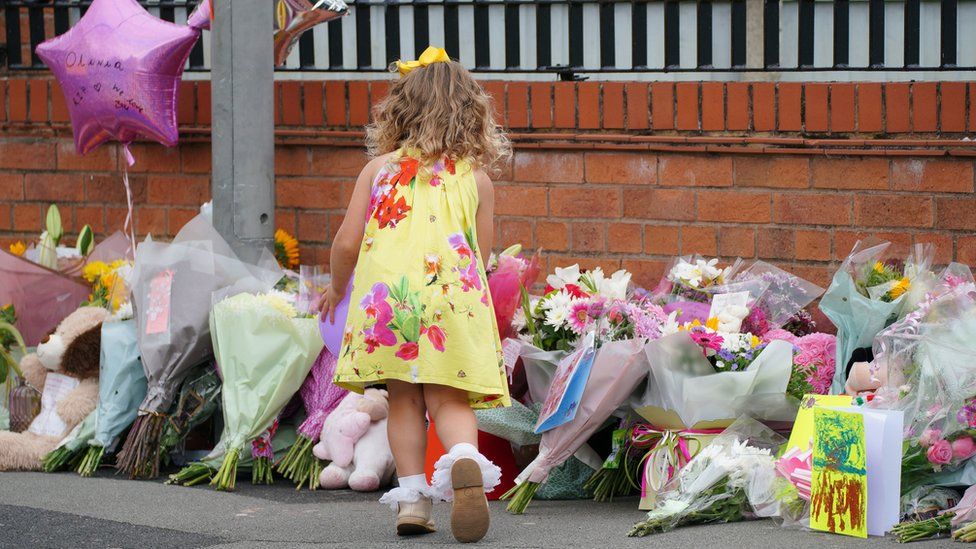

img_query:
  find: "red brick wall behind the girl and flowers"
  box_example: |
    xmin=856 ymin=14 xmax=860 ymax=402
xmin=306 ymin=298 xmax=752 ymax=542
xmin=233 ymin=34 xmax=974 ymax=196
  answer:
xmin=0 ymin=75 xmax=976 ymax=294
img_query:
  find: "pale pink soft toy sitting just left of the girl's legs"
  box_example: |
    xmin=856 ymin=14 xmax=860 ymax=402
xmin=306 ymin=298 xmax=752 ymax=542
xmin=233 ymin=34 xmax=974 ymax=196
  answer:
xmin=312 ymin=389 xmax=395 ymax=492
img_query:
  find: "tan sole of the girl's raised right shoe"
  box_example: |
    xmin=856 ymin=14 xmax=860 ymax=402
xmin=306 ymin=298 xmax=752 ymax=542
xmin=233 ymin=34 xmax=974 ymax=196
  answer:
xmin=451 ymin=458 xmax=491 ymax=543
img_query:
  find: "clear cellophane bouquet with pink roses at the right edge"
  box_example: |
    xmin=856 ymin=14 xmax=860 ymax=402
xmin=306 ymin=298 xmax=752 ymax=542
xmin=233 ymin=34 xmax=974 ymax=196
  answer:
xmin=870 ymin=276 xmax=976 ymax=493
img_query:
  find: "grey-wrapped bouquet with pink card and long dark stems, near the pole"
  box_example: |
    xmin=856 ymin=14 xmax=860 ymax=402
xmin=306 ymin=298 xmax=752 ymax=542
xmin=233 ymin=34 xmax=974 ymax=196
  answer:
xmin=118 ymin=216 xmax=281 ymax=478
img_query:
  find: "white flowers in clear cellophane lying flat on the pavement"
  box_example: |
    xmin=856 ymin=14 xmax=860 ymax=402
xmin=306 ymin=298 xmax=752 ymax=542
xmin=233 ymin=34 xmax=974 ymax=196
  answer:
xmin=630 ymin=417 xmax=804 ymax=536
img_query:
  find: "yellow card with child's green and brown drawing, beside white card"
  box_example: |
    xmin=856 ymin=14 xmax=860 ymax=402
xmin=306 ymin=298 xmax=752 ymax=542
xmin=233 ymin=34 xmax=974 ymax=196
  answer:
xmin=810 ymin=407 xmax=868 ymax=538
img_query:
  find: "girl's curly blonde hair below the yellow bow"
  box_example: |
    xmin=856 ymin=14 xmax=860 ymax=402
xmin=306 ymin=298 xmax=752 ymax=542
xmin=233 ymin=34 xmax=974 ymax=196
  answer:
xmin=366 ymin=61 xmax=512 ymax=171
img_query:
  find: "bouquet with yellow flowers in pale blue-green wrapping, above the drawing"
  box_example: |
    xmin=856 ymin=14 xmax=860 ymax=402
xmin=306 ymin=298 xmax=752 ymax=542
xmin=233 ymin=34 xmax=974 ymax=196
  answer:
xmin=820 ymin=240 xmax=935 ymax=393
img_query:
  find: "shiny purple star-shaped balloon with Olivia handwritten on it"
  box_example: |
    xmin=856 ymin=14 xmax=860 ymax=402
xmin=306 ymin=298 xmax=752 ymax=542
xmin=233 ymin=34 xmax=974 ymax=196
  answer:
xmin=37 ymin=0 xmax=209 ymax=154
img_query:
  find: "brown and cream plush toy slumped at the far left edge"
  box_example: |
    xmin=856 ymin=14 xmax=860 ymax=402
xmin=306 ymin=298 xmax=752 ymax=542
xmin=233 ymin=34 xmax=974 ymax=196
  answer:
xmin=0 ymin=307 xmax=110 ymax=471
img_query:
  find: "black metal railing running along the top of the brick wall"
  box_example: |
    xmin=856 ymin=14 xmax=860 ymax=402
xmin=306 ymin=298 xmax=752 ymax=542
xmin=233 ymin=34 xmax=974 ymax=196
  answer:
xmin=0 ymin=0 xmax=976 ymax=79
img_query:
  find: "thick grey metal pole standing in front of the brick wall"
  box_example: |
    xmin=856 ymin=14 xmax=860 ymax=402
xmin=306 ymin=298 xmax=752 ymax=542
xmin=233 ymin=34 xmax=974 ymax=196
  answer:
xmin=210 ymin=0 xmax=275 ymax=262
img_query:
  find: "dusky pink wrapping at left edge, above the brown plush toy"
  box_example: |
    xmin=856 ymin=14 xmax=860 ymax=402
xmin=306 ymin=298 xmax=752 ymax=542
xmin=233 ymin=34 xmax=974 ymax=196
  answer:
xmin=0 ymin=250 xmax=90 ymax=347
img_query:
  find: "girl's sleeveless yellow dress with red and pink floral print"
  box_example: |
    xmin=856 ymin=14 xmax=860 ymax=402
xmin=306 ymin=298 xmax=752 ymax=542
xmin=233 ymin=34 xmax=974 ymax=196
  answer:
xmin=335 ymin=151 xmax=510 ymax=408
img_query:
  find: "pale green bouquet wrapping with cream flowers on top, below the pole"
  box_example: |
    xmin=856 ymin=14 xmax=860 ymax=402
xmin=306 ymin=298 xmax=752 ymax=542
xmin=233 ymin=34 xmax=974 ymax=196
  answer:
xmin=210 ymin=293 xmax=323 ymax=489
